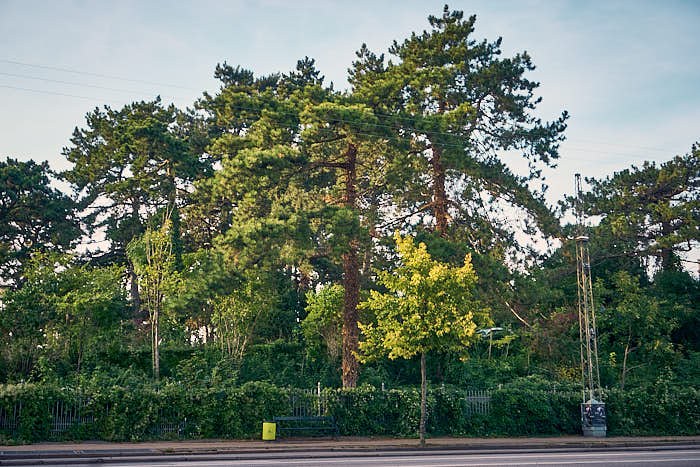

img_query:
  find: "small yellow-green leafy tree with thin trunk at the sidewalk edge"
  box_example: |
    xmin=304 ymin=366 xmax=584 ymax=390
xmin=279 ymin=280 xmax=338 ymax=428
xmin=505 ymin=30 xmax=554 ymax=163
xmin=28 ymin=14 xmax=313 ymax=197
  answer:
xmin=360 ymin=233 xmax=488 ymax=444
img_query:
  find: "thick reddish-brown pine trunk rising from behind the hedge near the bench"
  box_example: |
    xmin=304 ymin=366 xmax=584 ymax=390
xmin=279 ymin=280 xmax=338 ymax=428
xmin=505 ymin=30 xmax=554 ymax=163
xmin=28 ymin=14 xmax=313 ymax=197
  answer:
xmin=342 ymin=143 xmax=360 ymax=388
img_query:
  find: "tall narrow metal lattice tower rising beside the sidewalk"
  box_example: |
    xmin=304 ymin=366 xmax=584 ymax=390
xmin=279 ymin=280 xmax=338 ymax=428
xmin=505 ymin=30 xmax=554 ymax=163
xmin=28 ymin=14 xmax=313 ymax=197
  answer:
xmin=575 ymin=174 xmax=603 ymax=403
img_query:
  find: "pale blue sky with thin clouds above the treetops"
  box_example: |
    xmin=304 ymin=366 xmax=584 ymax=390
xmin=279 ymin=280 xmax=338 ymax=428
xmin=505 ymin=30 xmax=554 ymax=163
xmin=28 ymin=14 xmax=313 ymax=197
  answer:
xmin=0 ymin=0 xmax=700 ymax=205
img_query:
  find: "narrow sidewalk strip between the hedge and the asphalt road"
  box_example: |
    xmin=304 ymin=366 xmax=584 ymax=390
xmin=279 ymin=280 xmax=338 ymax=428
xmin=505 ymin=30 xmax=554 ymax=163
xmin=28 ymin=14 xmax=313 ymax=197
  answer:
xmin=0 ymin=436 xmax=700 ymax=459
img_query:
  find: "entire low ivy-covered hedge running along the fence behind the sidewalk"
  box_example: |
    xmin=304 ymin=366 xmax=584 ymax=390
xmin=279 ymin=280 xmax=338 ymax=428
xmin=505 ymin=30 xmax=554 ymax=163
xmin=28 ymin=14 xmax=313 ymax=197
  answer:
xmin=0 ymin=383 xmax=700 ymax=443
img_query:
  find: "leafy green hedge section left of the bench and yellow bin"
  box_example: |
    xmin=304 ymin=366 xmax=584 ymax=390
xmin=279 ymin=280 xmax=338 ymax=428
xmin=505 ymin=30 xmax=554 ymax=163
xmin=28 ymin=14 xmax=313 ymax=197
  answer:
xmin=0 ymin=383 xmax=289 ymax=441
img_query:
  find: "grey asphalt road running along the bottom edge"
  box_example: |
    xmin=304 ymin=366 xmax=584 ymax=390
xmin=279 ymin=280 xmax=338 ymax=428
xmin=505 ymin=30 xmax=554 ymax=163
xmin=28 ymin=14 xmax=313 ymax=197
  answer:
xmin=5 ymin=445 xmax=700 ymax=467
